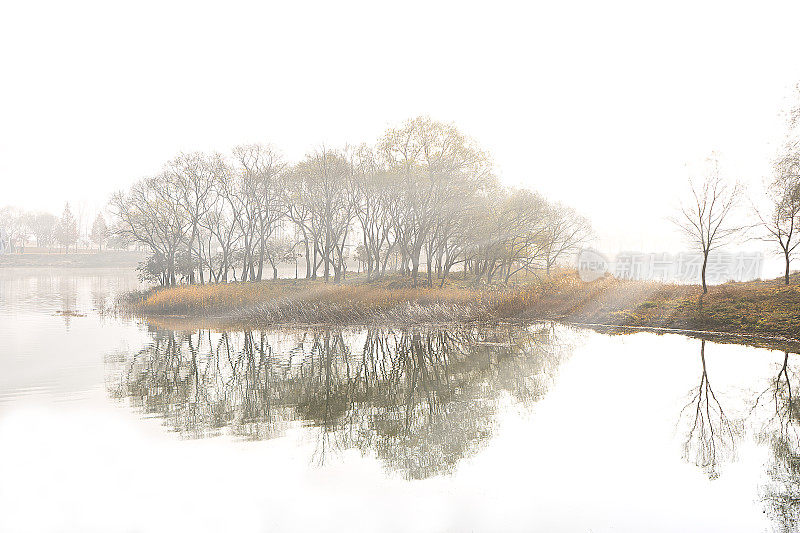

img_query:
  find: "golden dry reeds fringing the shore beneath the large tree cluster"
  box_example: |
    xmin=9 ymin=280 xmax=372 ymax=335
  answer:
xmin=126 ymin=280 xmax=530 ymax=325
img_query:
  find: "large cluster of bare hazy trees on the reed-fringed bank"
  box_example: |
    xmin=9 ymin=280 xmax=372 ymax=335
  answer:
xmin=111 ymin=117 xmax=590 ymax=285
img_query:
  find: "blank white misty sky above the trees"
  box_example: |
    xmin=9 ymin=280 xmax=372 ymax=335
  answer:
xmin=0 ymin=1 xmax=800 ymax=270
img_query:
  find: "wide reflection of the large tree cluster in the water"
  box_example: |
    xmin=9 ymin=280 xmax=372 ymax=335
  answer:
xmin=108 ymin=325 xmax=574 ymax=479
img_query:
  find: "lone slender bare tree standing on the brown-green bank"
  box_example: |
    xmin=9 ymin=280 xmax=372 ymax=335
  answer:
xmin=672 ymin=153 xmax=742 ymax=294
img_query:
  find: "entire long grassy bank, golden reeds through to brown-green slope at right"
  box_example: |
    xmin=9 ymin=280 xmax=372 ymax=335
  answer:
xmin=127 ymin=273 xmax=800 ymax=337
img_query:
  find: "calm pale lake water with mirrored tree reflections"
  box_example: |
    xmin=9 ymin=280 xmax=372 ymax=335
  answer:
xmin=0 ymin=269 xmax=800 ymax=532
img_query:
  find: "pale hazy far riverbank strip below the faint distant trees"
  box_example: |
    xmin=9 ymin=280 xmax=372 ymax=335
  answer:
xmin=0 ymin=250 xmax=146 ymax=268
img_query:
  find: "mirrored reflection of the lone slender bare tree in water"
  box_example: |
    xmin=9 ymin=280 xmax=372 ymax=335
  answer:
xmin=680 ymin=340 xmax=737 ymax=479
